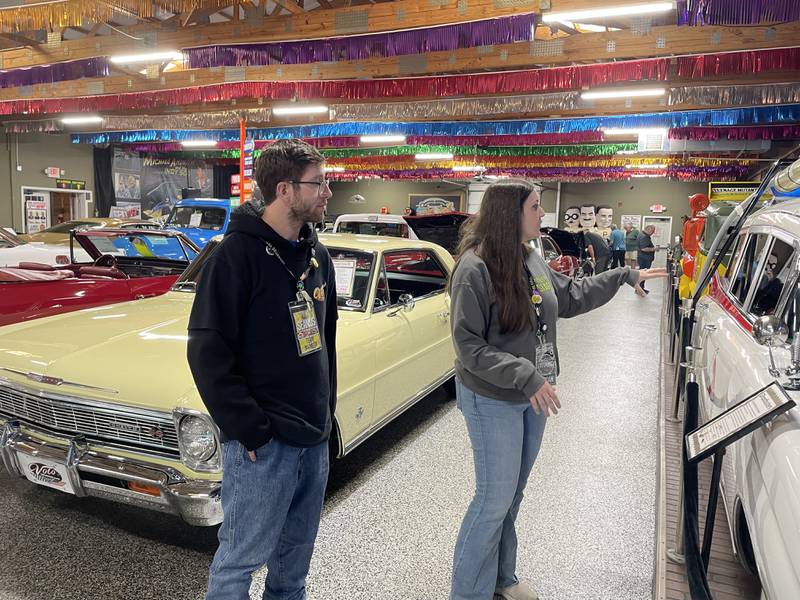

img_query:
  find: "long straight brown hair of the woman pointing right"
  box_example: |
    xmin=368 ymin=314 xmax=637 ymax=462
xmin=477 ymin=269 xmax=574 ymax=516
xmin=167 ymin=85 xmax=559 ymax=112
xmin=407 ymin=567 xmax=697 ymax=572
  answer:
xmin=458 ymin=179 xmax=536 ymax=333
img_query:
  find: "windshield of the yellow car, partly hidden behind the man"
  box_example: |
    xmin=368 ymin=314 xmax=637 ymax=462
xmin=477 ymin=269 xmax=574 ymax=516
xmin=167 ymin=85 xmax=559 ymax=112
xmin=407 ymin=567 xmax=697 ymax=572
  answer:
xmin=172 ymin=241 xmax=375 ymax=311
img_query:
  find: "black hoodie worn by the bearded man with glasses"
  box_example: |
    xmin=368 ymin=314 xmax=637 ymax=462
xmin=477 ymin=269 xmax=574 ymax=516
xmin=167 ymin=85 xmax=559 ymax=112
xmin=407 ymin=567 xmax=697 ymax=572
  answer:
xmin=188 ymin=203 xmax=338 ymax=450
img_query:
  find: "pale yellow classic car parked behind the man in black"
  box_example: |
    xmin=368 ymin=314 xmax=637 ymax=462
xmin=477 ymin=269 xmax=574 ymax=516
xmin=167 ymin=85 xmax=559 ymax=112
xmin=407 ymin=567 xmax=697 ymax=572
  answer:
xmin=0 ymin=234 xmax=454 ymax=525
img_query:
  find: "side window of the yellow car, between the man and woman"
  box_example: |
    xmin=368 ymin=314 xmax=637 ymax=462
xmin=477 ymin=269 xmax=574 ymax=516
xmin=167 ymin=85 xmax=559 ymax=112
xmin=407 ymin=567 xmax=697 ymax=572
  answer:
xmin=376 ymin=250 xmax=447 ymax=306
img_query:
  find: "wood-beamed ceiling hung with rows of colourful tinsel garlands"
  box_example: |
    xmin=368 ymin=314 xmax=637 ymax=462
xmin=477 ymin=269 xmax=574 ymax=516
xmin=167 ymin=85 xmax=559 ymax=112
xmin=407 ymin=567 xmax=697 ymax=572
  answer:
xmin=0 ymin=0 xmax=800 ymax=180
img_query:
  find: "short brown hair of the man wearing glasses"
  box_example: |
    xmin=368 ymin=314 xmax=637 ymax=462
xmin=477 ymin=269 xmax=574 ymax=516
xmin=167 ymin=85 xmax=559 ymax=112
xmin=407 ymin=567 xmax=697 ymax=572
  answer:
xmin=254 ymin=139 xmax=325 ymax=204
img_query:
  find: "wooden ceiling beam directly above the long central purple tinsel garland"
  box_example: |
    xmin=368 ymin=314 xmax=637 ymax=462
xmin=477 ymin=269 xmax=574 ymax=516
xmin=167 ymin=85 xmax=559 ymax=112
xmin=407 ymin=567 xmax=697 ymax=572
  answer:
xmin=2 ymin=0 xmax=648 ymax=69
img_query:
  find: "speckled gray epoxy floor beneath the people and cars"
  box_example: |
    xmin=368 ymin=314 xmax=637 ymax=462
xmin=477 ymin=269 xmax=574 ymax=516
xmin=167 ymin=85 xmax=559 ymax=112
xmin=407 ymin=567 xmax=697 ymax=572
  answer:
xmin=0 ymin=285 xmax=662 ymax=600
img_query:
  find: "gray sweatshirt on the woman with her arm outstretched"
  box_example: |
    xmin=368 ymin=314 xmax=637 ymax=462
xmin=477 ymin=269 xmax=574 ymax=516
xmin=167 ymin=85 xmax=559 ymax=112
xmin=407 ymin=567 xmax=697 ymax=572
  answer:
xmin=450 ymin=250 xmax=639 ymax=402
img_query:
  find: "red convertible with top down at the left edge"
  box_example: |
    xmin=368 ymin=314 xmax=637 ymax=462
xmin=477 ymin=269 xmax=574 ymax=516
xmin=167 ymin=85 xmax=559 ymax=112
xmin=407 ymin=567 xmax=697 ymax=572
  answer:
xmin=0 ymin=229 xmax=200 ymax=325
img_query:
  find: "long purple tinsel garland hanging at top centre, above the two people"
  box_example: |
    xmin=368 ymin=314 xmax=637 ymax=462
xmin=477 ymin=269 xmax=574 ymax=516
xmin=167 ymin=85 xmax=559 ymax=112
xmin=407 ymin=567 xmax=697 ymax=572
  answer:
xmin=183 ymin=14 xmax=536 ymax=69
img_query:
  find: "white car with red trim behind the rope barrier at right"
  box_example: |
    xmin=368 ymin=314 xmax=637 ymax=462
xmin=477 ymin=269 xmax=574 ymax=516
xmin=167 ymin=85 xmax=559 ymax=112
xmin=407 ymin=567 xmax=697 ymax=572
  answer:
xmin=691 ymin=161 xmax=800 ymax=600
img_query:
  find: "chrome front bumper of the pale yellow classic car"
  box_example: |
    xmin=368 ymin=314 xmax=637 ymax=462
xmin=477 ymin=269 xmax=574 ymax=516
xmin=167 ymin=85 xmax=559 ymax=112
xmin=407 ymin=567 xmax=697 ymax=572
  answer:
xmin=0 ymin=419 xmax=222 ymax=526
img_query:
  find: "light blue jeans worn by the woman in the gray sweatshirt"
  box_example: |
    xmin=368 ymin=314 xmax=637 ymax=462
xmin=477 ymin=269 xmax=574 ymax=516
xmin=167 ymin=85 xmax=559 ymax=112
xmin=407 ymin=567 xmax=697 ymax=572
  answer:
xmin=450 ymin=380 xmax=547 ymax=600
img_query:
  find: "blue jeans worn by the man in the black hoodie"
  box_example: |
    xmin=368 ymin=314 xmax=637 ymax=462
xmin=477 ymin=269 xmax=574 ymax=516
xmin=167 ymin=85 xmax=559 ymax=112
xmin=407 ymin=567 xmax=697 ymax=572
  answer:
xmin=206 ymin=439 xmax=328 ymax=600
